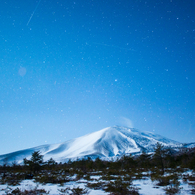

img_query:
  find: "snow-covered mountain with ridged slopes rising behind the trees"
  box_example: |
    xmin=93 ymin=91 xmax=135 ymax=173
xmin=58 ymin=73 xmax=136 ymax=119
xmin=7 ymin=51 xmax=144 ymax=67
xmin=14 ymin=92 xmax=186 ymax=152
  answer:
xmin=0 ymin=126 xmax=183 ymax=164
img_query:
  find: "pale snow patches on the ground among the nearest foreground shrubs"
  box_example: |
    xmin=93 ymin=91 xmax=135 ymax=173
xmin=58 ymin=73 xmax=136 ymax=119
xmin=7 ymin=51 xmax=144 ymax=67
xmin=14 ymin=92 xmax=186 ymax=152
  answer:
xmin=0 ymin=172 xmax=195 ymax=195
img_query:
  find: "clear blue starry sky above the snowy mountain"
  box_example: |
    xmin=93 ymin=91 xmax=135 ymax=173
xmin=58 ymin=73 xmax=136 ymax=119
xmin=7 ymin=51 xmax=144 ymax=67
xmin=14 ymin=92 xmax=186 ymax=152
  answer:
xmin=0 ymin=0 xmax=195 ymax=154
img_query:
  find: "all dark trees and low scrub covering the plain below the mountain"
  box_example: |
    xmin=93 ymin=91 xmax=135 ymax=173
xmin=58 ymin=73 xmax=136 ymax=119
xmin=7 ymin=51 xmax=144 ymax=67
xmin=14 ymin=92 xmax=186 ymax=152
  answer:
xmin=0 ymin=144 xmax=195 ymax=195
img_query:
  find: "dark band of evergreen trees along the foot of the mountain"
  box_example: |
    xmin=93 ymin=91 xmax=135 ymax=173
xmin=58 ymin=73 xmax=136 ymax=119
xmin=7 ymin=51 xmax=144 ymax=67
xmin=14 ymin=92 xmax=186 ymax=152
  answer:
xmin=0 ymin=143 xmax=195 ymax=175
